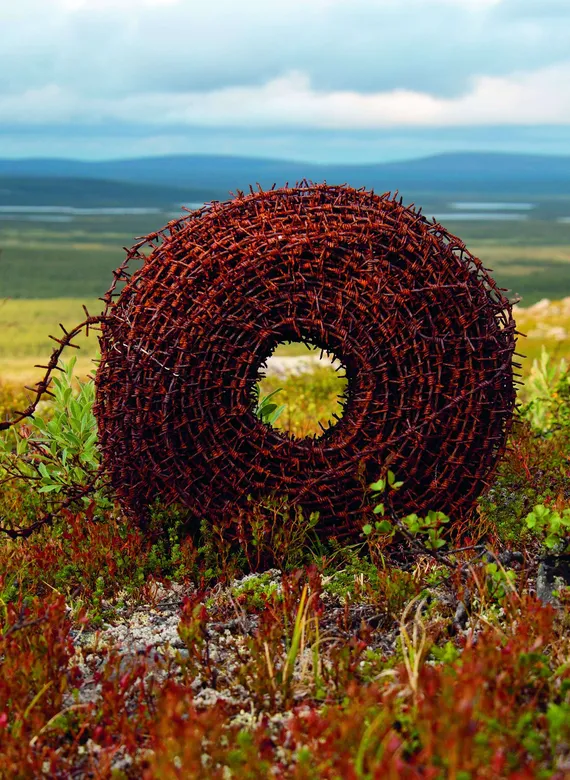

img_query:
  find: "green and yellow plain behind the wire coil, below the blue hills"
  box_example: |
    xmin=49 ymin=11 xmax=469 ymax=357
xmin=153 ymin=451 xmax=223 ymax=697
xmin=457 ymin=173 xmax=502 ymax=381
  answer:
xmin=0 ymin=204 xmax=570 ymax=381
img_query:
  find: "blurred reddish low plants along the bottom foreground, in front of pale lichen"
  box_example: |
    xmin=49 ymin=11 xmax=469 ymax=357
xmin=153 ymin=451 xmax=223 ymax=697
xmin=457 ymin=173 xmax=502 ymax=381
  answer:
xmin=0 ymin=571 xmax=570 ymax=778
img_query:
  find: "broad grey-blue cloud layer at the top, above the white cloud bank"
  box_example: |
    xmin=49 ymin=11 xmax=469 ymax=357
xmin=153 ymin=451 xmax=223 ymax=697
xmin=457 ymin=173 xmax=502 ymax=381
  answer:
xmin=0 ymin=0 xmax=570 ymax=98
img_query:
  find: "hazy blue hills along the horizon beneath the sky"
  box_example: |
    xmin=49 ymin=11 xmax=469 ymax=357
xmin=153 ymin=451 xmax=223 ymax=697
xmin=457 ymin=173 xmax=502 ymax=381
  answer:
xmin=0 ymin=153 xmax=570 ymax=206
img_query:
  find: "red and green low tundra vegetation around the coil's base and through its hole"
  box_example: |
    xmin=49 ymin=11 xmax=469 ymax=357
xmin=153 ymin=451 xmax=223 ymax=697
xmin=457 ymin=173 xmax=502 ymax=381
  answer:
xmin=0 ymin=344 xmax=570 ymax=778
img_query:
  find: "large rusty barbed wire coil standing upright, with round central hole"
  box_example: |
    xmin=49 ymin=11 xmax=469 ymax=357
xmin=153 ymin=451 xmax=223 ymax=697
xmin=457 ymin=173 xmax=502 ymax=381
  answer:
xmin=95 ymin=182 xmax=516 ymax=536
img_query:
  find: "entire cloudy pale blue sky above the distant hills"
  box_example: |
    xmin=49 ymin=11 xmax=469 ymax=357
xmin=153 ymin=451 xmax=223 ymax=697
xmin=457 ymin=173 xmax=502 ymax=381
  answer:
xmin=0 ymin=0 xmax=570 ymax=162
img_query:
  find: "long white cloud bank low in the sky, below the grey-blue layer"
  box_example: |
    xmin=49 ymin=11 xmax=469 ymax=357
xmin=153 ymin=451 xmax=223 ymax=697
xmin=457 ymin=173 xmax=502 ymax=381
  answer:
xmin=0 ymin=60 xmax=570 ymax=130
